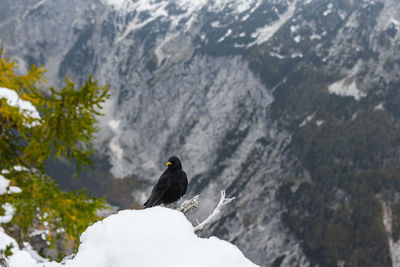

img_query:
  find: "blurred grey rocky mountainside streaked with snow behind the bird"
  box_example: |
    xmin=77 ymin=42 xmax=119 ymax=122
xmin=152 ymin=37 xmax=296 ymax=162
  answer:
xmin=0 ymin=0 xmax=400 ymax=266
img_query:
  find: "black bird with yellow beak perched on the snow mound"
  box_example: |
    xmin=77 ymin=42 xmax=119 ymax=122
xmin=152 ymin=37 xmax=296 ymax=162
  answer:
xmin=143 ymin=157 xmax=188 ymax=208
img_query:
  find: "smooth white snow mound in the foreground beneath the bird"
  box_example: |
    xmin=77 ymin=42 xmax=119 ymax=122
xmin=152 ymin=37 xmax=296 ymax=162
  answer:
xmin=9 ymin=207 xmax=257 ymax=267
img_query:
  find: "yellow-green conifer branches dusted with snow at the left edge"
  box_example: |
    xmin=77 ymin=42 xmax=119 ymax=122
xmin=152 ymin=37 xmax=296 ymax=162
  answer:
xmin=0 ymin=53 xmax=108 ymax=262
